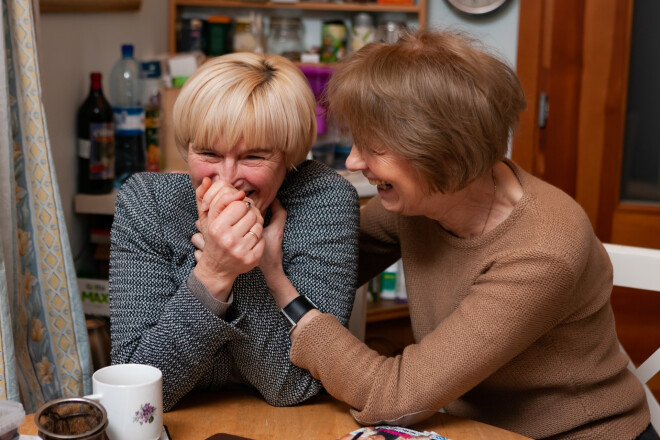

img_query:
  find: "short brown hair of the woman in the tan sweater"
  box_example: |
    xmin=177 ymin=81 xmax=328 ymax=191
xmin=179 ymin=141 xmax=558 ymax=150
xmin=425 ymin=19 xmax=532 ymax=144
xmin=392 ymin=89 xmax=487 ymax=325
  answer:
xmin=327 ymin=30 xmax=526 ymax=193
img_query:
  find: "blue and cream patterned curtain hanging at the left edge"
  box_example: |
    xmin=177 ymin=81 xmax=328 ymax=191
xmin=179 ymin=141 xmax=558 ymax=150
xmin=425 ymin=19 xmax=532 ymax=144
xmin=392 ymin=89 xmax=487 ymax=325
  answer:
xmin=0 ymin=0 xmax=92 ymax=413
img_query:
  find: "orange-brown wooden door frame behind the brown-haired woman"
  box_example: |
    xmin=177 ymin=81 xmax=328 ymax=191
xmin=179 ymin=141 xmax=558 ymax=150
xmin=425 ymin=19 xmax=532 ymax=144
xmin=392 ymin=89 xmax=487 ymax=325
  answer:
xmin=512 ymin=0 xmax=660 ymax=248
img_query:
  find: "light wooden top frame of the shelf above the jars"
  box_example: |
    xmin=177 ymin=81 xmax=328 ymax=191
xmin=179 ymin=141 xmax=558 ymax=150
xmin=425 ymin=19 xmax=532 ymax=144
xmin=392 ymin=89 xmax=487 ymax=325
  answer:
xmin=169 ymin=0 xmax=427 ymax=53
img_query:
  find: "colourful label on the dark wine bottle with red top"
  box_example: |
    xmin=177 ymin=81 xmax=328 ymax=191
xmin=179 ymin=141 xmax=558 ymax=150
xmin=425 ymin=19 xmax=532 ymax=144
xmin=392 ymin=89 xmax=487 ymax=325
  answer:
xmin=87 ymin=122 xmax=115 ymax=180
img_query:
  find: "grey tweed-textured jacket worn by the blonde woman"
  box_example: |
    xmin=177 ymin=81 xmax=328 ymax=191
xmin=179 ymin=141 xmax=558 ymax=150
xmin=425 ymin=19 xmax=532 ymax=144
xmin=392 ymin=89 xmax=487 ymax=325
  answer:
xmin=110 ymin=161 xmax=359 ymax=410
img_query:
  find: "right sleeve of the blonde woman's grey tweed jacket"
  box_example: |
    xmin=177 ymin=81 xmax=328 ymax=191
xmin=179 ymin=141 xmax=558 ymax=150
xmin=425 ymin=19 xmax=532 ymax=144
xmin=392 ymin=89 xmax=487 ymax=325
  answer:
xmin=230 ymin=163 xmax=359 ymax=406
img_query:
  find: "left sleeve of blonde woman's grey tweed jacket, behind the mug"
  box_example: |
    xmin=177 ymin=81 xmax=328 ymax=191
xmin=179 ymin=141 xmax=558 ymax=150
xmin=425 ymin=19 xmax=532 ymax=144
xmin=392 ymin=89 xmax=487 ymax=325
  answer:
xmin=110 ymin=175 xmax=244 ymax=410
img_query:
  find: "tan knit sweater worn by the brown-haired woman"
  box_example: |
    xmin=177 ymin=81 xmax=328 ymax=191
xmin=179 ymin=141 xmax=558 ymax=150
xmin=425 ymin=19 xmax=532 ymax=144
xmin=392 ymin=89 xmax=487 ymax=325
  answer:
xmin=291 ymin=162 xmax=649 ymax=440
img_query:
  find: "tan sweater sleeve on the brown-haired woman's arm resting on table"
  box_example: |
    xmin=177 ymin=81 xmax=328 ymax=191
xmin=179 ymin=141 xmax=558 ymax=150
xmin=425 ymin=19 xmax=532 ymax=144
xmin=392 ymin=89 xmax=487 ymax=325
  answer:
xmin=291 ymin=248 xmax=575 ymax=425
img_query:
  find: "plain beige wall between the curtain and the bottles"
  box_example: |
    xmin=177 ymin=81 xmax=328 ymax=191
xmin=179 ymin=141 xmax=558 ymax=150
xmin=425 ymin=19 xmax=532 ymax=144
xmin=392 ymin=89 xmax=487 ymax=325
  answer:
xmin=37 ymin=0 xmax=169 ymax=263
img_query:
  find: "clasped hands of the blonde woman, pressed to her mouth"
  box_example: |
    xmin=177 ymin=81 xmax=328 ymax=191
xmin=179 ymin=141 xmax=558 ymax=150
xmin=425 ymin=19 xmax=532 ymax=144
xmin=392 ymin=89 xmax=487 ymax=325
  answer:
xmin=193 ymin=178 xmax=265 ymax=301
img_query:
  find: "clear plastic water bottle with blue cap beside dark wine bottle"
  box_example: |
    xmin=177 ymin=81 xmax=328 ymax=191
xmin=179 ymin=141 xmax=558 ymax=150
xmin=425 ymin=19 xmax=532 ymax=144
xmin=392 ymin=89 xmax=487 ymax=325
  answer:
xmin=110 ymin=44 xmax=146 ymax=188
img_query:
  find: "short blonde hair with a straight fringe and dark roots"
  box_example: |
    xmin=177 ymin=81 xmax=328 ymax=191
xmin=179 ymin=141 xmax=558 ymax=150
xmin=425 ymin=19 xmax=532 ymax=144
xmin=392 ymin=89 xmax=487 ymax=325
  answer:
xmin=172 ymin=52 xmax=316 ymax=170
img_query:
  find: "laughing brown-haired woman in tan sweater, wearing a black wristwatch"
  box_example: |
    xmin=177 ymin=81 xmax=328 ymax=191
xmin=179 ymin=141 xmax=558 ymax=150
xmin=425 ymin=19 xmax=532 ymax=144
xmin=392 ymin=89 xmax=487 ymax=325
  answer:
xmin=253 ymin=30 xmax=657 ymax=440
